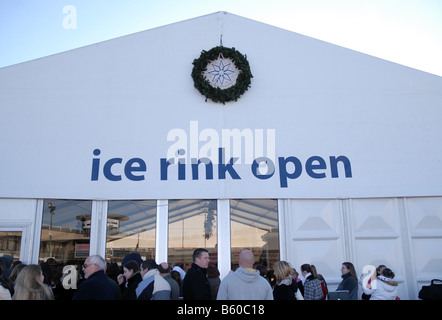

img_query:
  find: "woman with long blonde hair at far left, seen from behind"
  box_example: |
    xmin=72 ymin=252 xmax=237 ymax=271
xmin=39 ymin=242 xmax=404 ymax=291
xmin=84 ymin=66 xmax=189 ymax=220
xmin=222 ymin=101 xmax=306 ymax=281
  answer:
xmin=12 ymin=264 xmax=54 ymax=300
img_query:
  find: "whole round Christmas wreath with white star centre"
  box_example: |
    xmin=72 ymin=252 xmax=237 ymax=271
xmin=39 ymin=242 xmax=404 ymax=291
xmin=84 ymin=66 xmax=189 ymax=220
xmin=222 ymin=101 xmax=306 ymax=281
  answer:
xmin=192 ymin=46 xmax=253 ymax=104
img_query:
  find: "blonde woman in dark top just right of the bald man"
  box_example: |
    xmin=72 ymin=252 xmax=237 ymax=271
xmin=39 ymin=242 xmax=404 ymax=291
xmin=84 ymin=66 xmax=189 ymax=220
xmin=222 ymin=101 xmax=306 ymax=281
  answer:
xmin=273 ymin=261 xmax=304 ymax=300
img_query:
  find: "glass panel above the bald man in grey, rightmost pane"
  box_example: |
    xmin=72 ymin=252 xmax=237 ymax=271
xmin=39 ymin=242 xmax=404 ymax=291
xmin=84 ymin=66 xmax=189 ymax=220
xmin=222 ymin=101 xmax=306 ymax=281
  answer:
xmin=230 ymin=199 xmax=279 ymax=270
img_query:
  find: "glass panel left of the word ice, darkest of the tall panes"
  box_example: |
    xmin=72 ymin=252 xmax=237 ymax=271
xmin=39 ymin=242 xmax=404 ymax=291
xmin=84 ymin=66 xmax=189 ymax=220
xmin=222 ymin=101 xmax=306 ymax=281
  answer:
xmin=40 ymin=200 xmax=92 ymax=267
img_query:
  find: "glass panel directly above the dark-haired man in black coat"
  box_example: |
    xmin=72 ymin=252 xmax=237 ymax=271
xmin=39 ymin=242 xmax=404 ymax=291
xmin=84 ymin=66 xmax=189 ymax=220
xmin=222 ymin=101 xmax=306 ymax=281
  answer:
xmin=168 ymin=200 xmax=218 ymax=268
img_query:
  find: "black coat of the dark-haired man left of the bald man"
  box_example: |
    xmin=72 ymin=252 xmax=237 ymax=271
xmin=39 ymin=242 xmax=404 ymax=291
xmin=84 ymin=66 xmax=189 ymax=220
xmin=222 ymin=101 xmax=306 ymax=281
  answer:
xmin=183 ymin=263 xmax=212 ymax=300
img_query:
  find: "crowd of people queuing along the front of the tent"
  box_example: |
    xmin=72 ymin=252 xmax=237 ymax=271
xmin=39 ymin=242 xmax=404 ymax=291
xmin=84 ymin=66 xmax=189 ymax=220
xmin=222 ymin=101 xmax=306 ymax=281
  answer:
xmin=0 ymin=248 xmax=399 ymax=300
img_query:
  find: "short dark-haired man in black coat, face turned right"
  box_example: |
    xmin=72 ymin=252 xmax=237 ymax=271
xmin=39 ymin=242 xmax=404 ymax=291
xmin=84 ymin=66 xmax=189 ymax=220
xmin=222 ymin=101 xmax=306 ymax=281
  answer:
xmin=183 ymin=248 xmax=211 ymax=300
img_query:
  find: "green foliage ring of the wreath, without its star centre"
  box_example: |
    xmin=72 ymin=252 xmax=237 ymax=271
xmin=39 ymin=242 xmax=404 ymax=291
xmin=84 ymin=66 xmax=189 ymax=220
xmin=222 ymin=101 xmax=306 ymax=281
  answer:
xmin=192 ymin=46 xmax=253 ymax=104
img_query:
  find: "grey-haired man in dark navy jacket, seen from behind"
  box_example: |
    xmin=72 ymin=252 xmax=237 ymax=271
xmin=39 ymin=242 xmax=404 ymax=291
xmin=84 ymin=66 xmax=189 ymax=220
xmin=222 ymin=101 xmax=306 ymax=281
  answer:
xmin=72 ymin=255 xmax=116 ymax=300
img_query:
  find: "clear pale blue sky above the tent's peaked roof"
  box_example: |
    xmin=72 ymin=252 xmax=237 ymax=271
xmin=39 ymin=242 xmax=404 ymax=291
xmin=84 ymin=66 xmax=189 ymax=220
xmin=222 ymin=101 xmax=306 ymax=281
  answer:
xmin=0 ymin=0 xmax=442 ymax=76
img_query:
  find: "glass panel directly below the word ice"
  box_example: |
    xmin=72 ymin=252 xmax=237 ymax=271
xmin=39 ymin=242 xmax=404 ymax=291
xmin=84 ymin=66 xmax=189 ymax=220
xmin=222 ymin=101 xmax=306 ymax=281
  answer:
xmin=106 ymin=200 xmax=157 ymax=263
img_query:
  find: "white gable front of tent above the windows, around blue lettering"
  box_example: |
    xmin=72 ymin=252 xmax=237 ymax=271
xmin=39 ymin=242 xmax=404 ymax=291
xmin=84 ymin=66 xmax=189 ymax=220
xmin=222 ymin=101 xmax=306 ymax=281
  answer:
xmin=0 ymin=12 xmax=442 ymax=200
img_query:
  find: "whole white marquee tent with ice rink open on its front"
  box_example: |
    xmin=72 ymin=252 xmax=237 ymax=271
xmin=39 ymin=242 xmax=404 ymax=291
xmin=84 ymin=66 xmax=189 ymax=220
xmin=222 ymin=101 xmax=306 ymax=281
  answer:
xmin=0 ymin=12 xmax=442 ymax=299
